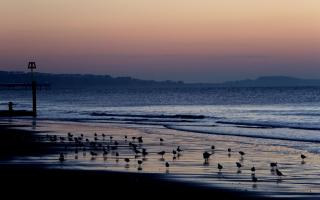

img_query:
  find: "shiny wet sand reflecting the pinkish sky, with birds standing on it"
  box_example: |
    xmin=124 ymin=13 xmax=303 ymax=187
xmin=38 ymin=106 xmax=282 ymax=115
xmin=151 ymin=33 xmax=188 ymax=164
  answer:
xmin=8 ymin=122 xmax=320 ymax=196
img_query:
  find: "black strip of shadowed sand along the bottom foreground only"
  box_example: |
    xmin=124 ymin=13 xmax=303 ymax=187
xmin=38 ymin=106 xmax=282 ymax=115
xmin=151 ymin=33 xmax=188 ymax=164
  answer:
xmin=0 ymin=165 xmax=268 ymax=200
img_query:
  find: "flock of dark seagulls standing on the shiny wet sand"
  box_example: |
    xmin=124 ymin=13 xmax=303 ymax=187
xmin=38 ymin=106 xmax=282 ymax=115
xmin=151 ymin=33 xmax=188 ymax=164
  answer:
xmin=46 ymin=133 xmax=307 ymax=182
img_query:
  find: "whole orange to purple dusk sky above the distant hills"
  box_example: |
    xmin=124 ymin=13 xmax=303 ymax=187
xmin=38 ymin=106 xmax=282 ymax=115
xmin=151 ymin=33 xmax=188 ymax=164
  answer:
xmin=0 ymin=0 xmax=320 ymax=82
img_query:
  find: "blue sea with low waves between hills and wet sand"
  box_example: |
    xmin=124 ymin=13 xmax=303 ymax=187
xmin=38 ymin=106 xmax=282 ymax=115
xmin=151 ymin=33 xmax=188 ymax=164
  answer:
xmin=0 ymin=86 xmax=320 ymax=145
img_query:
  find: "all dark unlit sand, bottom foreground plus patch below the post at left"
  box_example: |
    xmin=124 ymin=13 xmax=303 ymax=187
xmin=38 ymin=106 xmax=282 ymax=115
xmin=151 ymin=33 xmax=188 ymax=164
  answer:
xmin=0 ymin=124 xmax=261 ymax=199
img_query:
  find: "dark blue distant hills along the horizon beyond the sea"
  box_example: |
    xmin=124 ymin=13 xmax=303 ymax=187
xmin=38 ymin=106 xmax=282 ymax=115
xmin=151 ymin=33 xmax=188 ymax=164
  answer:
xmin=0 ymin=71 xmax=320 ymax=88
